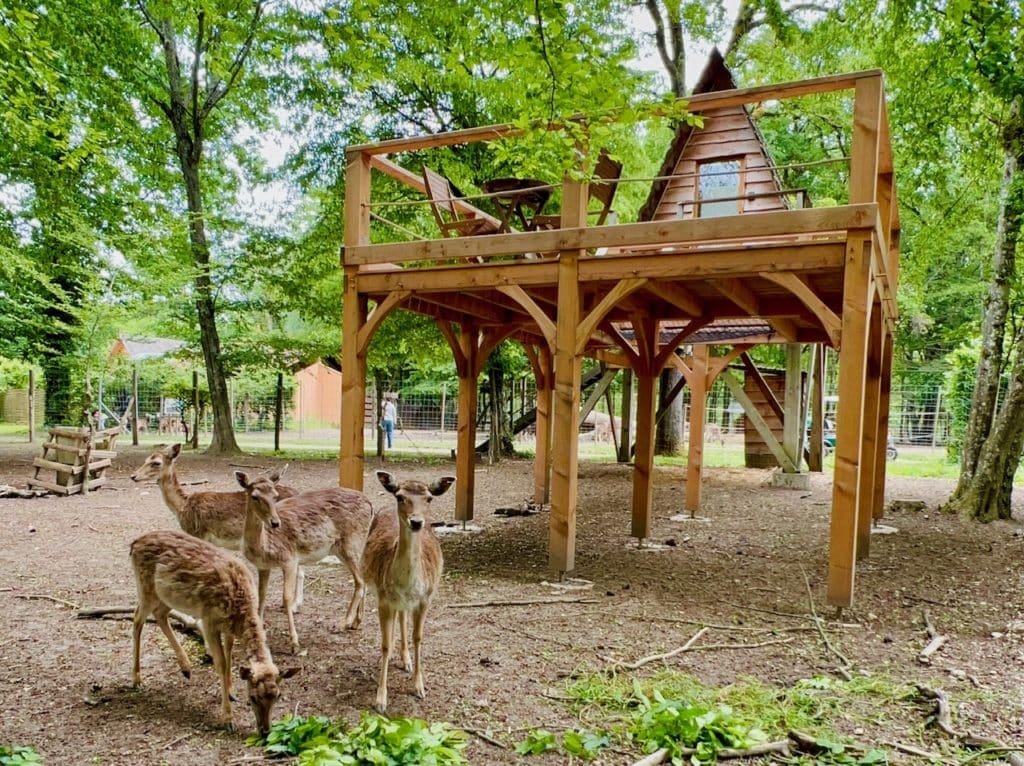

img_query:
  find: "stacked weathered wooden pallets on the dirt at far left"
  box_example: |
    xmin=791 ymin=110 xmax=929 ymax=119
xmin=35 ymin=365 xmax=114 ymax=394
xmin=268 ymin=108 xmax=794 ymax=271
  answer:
xmin=29 ymin=426 xmax=121 ymax=495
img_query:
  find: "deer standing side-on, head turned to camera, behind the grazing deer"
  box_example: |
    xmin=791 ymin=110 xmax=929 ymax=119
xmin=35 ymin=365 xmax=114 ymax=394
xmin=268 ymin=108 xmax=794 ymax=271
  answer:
xmin=234 ymin=471 xmax=374 ymax=652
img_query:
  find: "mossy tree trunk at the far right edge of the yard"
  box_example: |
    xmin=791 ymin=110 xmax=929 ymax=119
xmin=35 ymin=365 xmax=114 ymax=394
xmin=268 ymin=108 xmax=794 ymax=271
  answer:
xmin=946 ymin=100 xmax=1024 ymax=521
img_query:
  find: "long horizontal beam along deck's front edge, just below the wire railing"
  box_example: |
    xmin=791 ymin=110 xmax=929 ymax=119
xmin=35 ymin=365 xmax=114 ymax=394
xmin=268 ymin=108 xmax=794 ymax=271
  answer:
xmin=344 ymin=200 xmax=879 ymax=266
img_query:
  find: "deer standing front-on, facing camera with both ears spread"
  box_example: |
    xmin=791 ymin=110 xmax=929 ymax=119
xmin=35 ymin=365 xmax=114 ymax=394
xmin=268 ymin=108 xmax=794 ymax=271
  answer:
xmin=362 ymin=471 xmax=455 ymax=713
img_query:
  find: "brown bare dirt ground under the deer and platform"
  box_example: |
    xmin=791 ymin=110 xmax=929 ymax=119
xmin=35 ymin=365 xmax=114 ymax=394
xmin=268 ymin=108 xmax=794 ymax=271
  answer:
xmin=0 ymin=445 xmax=1024 ymax=764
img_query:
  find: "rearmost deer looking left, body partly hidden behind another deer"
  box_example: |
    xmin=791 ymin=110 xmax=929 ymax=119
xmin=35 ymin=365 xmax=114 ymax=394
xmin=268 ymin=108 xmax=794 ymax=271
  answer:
xmin=131 ymin=444 xmax=305 ymax=609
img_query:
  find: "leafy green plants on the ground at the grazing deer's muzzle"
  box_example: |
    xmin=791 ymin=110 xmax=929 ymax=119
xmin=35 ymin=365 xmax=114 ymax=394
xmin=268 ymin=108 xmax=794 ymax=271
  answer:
xmin=247 ymin=714 xmax=467 ymax=766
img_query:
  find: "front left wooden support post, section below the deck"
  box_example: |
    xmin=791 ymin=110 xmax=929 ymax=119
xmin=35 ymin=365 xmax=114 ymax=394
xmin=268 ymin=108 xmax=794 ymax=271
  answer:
xmin=338 ymin=266 xmax=367 ymax=492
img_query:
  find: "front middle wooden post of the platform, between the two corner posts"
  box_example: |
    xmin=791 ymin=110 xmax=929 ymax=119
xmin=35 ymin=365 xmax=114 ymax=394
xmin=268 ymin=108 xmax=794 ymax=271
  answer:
xmin=548 ymin=171 xmax=587 ymax=573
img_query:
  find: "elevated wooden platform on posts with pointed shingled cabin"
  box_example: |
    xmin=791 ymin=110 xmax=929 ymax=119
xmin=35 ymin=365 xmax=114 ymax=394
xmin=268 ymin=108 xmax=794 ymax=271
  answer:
xmin=340 ymin=62 xmax=899 ymax=605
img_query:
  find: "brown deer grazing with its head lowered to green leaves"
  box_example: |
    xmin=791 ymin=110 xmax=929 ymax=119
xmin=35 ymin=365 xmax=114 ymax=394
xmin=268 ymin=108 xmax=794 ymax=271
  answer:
xmin=131 ymin=531 xmax=298 ymax=735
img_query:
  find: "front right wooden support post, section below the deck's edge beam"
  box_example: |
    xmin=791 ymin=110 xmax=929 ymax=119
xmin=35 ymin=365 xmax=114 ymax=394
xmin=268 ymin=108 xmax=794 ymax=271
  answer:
xmin=826 ymin=232 xmax=871 ymax=606
